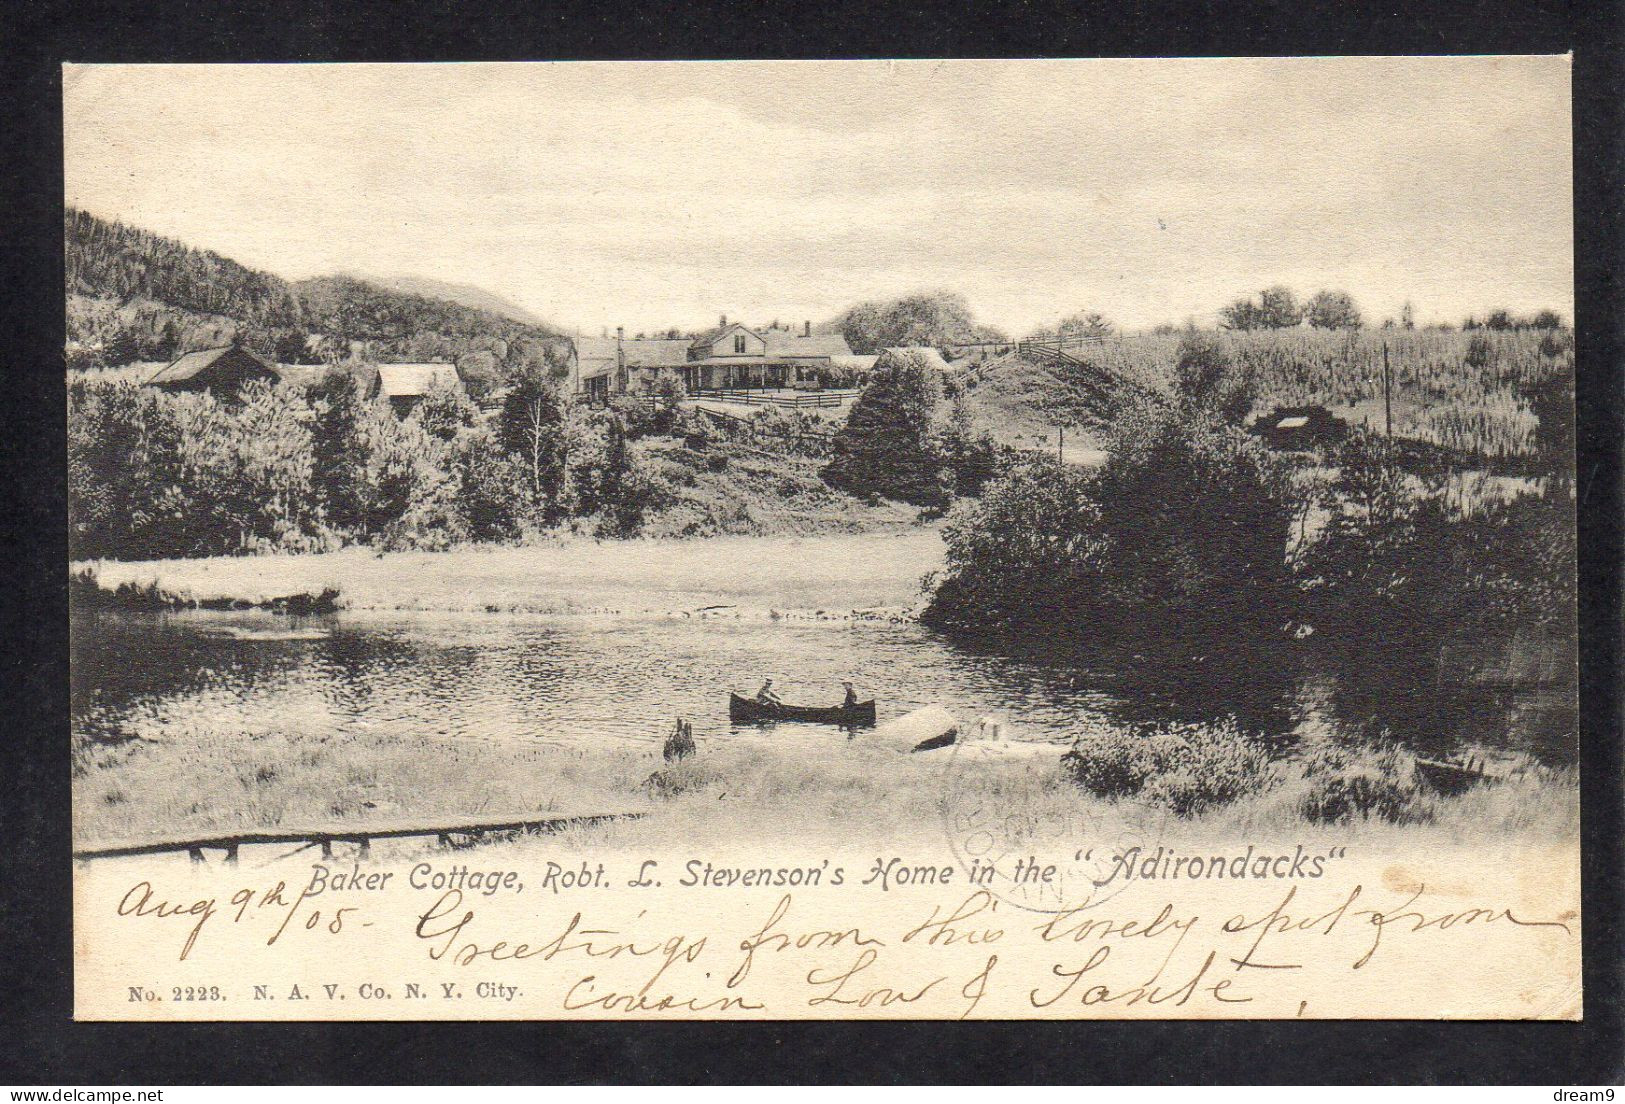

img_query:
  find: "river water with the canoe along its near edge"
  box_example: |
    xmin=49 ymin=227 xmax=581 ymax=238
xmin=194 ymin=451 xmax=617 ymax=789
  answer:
xmin=72 ymin=611 xmax=1575 ymax=763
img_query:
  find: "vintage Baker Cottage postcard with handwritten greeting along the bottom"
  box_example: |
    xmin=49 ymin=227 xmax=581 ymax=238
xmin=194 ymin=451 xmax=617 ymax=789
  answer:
xmin=63 ymin=57 xmax=1584 ymax=1021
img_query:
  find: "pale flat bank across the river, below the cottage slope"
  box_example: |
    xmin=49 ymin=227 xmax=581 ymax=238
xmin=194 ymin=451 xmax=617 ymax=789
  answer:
xmin=73 ymin=525 xmax=943 ymax=613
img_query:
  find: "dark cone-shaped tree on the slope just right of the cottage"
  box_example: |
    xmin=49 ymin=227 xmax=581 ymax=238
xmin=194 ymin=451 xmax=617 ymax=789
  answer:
xmin=824 ymin=351 xmax=949 ymax=507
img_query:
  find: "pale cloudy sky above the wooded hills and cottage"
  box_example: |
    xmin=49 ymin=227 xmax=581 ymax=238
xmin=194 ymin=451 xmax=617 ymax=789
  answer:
xmin=63 ymin=57 xmax=1573 ymax=335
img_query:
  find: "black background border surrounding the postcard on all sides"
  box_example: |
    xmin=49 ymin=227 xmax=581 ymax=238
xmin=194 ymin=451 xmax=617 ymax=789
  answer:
xmin=0 ymin=0 xmax=1625 ymax=1084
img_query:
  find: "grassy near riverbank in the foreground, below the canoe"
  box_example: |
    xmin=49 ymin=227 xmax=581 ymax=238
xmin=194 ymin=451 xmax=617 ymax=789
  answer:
xmin=73 ymin=730 xmax=1578 ymax=847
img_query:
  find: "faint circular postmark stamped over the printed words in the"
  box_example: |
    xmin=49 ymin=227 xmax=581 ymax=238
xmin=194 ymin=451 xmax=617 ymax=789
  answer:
xmin=943 ymin=740 xmax=1167 ymax=914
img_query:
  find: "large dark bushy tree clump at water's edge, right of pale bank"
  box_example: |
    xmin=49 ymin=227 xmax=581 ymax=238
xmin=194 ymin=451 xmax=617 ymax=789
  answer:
xmin=926 ymin=403 xmax=1292 ymax=644
